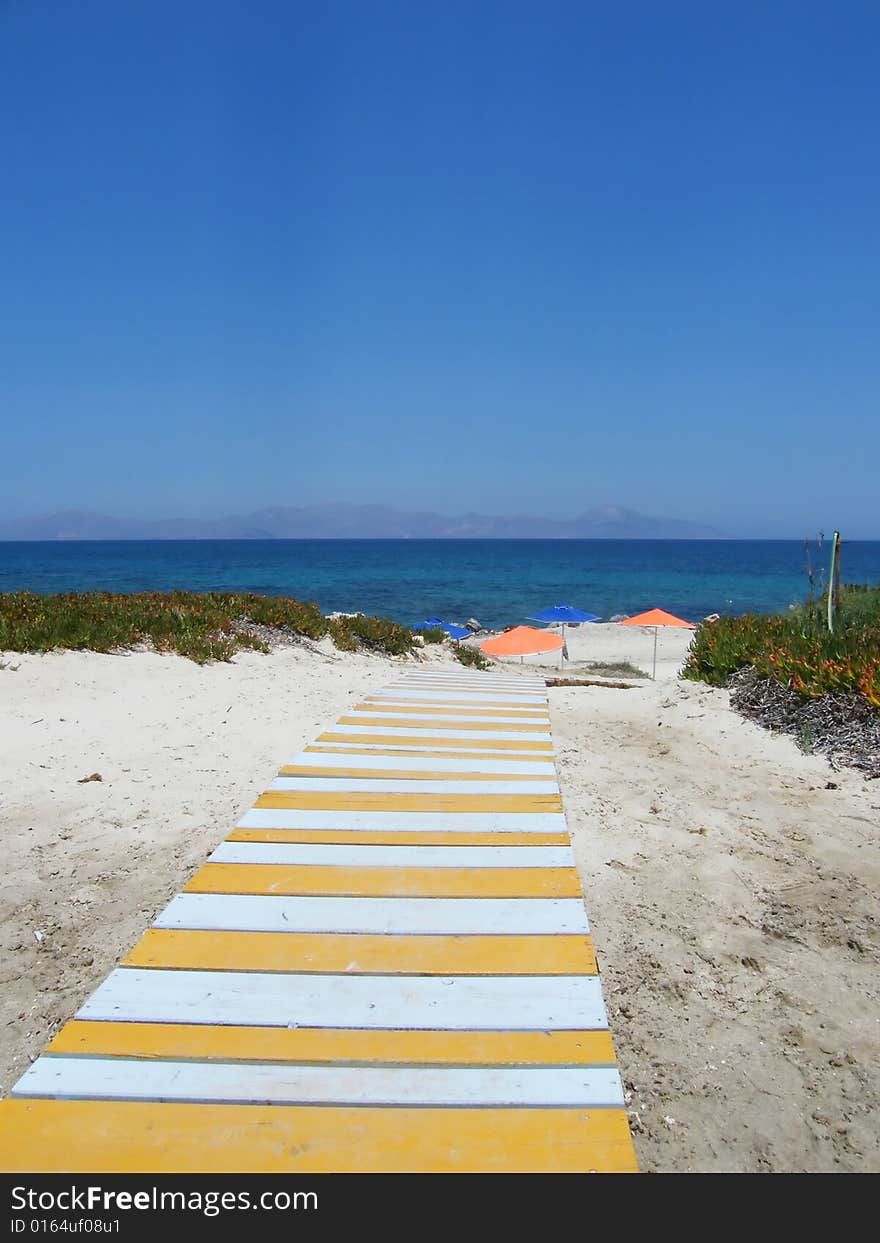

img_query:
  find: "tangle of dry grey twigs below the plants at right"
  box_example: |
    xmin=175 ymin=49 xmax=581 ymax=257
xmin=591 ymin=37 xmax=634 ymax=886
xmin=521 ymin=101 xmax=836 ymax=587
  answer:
xmin=730 ymin=669 xmax=880 ymax=777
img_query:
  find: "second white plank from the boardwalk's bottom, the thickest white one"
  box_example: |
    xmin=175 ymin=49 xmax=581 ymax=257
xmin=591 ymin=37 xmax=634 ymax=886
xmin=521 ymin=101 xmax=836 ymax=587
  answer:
xmin=77 ymin=967 xmax=608 ymax=1032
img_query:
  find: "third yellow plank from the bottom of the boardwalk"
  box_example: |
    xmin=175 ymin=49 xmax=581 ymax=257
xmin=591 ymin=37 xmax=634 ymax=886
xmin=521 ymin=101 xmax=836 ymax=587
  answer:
xmin=123 ymin=929 xmax=597 ymax=976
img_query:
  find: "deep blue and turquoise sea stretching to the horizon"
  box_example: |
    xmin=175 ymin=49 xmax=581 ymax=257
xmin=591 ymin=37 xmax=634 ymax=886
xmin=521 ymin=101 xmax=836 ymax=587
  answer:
xmin=0 ymin=539 xmax=880 ymax=626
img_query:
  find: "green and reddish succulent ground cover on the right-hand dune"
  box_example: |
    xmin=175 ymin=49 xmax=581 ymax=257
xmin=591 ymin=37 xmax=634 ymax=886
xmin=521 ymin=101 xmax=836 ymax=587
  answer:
xmin=682 ymin=587 xmax=880 ymax=709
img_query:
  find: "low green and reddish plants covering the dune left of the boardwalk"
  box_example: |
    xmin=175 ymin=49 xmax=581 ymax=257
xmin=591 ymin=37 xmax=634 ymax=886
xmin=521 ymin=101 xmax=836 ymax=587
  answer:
xmin=0 ymin=592 xmax=413 ymax=664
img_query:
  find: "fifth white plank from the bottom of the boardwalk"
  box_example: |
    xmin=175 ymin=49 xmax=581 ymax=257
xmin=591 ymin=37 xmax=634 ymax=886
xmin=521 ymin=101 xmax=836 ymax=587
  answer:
xmin=236 ymin=807 xmax=568 ymax=833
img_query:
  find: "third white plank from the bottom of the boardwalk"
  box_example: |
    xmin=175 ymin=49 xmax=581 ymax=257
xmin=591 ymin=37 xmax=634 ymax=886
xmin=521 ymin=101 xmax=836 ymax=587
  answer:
xmin=154 ymin=894 xmax=589 ymax=936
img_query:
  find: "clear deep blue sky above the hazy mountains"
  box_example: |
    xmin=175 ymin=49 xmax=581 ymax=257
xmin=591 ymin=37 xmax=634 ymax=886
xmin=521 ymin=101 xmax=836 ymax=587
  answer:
xmin=0 ymin=0 xmax=880 ymax=538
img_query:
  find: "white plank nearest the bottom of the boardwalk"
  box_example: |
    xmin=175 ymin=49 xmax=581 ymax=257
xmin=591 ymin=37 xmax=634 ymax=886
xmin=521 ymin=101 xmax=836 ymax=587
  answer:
xmin=14 ymin=1055 xmax=624 ymax=1109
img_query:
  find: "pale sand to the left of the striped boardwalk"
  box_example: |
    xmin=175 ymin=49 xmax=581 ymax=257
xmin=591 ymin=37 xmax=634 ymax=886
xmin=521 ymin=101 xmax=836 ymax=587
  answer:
xmin=0 ymin=644 xmax=410 ymax=1091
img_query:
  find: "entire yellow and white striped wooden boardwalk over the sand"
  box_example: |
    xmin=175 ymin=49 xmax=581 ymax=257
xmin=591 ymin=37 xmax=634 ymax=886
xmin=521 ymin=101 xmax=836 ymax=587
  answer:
xmin=0 ymin=670 xmax=635 ymax=1172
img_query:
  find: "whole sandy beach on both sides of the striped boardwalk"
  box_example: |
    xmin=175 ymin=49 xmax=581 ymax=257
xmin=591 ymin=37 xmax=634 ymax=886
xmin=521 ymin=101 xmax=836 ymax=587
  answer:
xmin=0 ymin=625 xmax=880 ymax=1171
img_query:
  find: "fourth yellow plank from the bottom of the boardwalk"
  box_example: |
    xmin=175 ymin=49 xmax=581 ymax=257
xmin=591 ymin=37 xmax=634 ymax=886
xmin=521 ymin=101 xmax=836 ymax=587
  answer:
xmin=184 ymin=863 xmax=580 ymax=897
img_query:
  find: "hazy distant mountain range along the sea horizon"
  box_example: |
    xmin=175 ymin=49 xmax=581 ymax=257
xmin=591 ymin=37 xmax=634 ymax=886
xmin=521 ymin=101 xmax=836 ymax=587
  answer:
xmin=0 ymin=505 xmax=725 ymax=539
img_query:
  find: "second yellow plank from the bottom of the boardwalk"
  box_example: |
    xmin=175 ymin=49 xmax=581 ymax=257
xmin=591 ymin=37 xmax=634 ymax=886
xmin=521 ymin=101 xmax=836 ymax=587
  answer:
xmin=47 ymin=1019 xmax=615 ymax=1066
